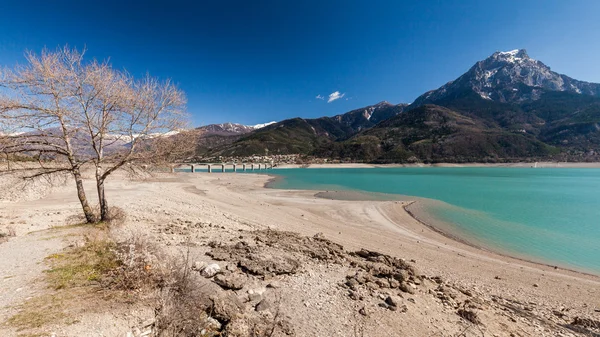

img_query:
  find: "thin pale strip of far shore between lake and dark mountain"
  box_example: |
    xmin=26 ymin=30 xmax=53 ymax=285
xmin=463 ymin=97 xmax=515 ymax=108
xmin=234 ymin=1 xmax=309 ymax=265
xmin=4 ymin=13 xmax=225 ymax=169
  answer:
xmin=277 ymin=162 xmax=600 ymax=169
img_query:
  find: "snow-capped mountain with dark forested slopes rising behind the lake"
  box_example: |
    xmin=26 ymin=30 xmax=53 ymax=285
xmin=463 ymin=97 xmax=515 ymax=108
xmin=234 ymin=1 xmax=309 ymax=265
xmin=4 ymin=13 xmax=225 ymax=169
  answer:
xmin=195 ymin=49 xmax=600 ymax=163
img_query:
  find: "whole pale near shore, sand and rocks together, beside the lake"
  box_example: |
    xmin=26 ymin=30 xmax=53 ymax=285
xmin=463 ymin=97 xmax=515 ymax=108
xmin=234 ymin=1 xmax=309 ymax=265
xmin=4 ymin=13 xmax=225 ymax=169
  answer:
xmin=0 ymin=174 xmax=600 ymax=336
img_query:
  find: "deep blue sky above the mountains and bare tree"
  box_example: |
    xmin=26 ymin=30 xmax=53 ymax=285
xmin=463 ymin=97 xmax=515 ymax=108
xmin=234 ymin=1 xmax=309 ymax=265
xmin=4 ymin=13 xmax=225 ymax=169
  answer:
xmin=0 ymin=0 xmax=600 ymax=125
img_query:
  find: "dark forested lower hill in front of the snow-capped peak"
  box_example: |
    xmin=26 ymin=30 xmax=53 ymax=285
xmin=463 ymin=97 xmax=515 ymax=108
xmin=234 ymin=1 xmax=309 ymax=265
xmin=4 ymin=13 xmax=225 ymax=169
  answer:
xmin=317 ymin=105 xmax=554 ymax=163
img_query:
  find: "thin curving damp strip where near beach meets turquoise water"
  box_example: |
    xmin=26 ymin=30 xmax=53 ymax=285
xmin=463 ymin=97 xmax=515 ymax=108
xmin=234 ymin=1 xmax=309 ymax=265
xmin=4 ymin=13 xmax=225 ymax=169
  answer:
xmin=263 ymin=174 xmax=600 ymax=278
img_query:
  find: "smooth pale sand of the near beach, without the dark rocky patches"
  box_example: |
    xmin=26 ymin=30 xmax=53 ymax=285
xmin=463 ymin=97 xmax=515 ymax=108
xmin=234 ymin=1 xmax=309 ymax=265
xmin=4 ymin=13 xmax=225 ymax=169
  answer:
xmin=0 ymin=173 xmax=600 ymax=336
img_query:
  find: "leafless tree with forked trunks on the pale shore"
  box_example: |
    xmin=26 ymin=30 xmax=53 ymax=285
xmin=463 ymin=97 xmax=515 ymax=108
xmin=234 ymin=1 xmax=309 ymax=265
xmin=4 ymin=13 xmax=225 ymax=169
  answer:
xmin=0 ymin=47 xmax=187 ymax=222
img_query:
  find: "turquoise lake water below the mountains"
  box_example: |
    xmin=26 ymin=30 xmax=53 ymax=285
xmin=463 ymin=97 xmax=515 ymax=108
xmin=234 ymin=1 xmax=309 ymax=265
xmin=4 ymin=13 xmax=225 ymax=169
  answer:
xmin=268 ymin=167 xmax=600 ymax=274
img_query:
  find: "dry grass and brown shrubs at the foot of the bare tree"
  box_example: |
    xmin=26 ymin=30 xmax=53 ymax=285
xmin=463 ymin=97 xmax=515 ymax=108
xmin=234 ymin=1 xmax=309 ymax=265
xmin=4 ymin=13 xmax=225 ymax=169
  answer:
xmin=7 ymin=211 xmax=218 ymax=337
